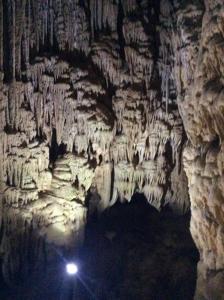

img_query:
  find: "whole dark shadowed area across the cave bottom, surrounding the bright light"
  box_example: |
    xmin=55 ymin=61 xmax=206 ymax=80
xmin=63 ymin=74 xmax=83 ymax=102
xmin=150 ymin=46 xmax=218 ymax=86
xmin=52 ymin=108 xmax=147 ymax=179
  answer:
xmin=0 ymin=194 xmax=199 ymax=300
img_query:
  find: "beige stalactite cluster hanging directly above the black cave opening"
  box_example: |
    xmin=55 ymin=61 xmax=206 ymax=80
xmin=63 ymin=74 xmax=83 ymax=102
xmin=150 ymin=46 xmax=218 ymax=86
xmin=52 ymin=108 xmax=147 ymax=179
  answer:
xmin=110 ymin=88 xmax=189 ymax=212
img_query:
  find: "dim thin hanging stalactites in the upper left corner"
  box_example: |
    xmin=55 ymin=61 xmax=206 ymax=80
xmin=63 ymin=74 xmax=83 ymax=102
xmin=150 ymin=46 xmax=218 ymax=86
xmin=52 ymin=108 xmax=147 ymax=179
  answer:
xmin=0 ymin=0 xmax=90 ymax=79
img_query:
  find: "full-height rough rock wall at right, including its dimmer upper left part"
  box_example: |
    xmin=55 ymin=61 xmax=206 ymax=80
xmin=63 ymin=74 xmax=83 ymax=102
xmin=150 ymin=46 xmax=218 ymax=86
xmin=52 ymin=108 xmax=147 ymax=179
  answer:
xmin=163 ymin=1 xmax=224 ymax=299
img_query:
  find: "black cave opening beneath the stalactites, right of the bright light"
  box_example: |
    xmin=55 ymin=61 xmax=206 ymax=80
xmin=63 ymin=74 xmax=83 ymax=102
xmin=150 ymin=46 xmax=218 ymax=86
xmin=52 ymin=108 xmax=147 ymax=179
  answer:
xmin=74 ymin=194 xmax=199 ymax=300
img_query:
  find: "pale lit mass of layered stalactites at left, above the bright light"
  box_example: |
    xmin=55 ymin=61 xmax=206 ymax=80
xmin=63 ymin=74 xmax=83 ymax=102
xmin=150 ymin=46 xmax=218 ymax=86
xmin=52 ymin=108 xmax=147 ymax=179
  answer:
xmin=0 ymin=57 xmax=114 ymax=220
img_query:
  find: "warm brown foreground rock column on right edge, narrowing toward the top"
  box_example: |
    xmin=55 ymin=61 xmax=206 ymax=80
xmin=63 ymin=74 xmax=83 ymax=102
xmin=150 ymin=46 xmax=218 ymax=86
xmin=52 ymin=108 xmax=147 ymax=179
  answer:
xmin=180 ymin=1 xmax=224 ymax=299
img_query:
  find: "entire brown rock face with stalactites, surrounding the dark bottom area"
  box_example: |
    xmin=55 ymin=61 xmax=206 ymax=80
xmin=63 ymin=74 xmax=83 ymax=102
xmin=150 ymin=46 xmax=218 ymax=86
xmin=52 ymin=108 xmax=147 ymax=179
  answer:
xmin=0 ymin=0 xmax=224 ymax=300
